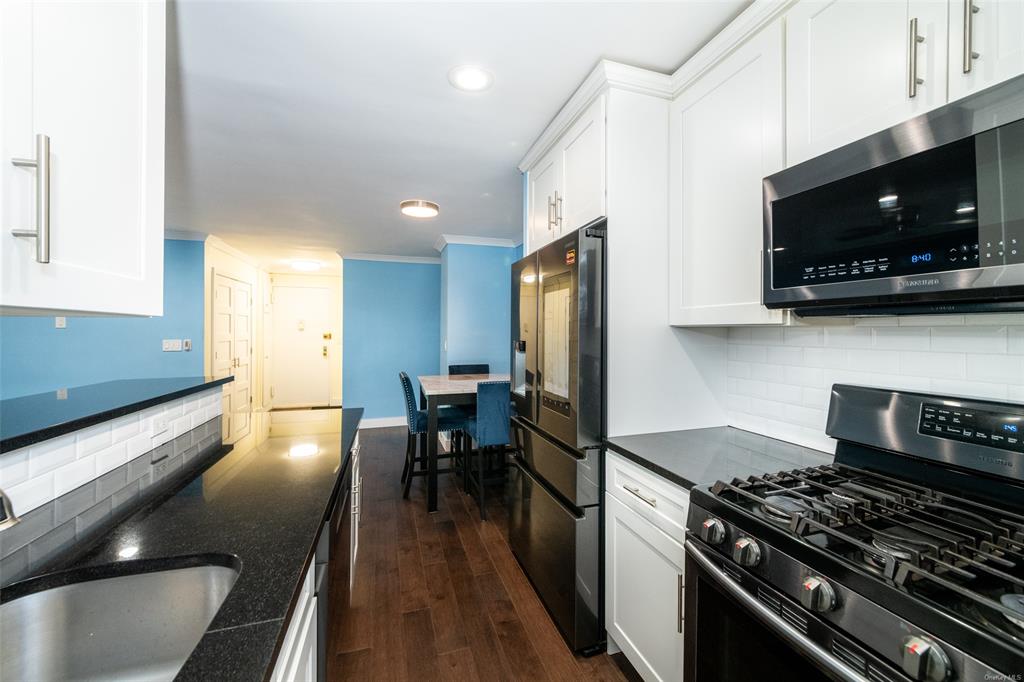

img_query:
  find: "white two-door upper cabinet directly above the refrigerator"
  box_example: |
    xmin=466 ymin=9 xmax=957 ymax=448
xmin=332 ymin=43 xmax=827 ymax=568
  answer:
xmin=525 ymin=94 xmax=607 ymax=253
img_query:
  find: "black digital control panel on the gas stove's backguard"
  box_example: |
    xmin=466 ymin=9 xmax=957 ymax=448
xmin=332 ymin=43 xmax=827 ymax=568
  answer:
xmin=918 ymin=402 xmax=1024 ymax=453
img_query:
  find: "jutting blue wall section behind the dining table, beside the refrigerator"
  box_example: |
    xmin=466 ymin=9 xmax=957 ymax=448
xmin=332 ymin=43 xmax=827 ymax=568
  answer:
xmin=441 ymin=244 xmax=522 ymax=373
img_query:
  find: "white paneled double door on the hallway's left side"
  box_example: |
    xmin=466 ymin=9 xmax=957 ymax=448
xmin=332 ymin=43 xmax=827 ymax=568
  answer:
xmin=212 ymin=274 xmax=252 ymax=442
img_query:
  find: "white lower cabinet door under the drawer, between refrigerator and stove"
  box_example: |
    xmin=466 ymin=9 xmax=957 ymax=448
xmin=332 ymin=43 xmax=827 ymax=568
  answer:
xmin=604 ymin=494 xmax=684 ymax=682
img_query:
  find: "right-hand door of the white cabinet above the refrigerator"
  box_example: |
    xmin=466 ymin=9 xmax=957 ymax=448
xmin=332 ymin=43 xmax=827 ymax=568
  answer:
xmin=555 ymin=95 xmax=605 ymax=235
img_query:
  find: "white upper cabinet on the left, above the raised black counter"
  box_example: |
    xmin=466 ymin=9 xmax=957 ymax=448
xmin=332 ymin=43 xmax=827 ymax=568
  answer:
xmin=0 ymin=0 xmax=166 ymax=315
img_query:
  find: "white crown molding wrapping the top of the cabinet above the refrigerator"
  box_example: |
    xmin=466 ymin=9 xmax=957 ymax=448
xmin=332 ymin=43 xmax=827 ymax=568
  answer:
xmin=519 ymin=59 xmax=672 ymax=173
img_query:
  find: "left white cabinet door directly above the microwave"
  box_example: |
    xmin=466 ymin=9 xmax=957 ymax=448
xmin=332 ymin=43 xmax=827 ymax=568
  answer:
xmin=785 ymin=0 xmax=948 ymax=166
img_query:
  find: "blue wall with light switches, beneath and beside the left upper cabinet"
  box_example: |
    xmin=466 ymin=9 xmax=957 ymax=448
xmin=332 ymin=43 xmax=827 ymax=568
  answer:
xmin=0 ymin=240 xmax=204 ymax=398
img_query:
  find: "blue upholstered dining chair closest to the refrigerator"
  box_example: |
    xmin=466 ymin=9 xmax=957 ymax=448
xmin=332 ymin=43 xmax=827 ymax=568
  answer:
xmin=463 ymin=381 xmax=512 ymax=519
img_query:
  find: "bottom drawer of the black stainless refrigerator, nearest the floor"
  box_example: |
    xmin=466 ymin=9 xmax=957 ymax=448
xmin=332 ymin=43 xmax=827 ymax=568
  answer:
xmin=509 ymin=458 xmax=602 ymax=651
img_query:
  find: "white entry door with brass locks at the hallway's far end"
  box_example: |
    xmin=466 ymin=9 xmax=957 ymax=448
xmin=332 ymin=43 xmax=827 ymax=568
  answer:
xmin=272 ymin=286 xmax=335 ymax=408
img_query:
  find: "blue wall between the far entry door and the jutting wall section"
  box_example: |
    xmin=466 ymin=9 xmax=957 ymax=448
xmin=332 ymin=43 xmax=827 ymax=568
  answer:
xmin=342 ymin=259 xmax=441 ymax=419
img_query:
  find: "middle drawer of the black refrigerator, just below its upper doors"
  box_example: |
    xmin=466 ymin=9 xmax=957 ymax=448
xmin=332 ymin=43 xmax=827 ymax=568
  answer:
xmin=515 ymin=420 xmax=601 ymax=507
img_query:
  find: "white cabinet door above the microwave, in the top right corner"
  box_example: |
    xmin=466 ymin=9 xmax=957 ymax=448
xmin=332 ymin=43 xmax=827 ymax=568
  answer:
xmin=949 ymin=0 xmax=1024 ymax=100
